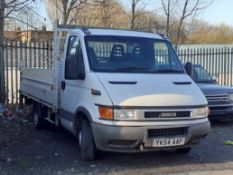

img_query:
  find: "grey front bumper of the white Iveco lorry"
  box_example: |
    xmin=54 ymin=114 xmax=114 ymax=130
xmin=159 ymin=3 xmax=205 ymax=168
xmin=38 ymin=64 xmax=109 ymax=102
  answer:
xmin=92 ymin=120 xmax=210 ymax=152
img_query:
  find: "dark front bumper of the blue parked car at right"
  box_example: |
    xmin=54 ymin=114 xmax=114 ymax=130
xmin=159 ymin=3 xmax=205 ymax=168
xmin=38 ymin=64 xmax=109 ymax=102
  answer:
xmin=209 ymin=106 xmax=233 ymax=120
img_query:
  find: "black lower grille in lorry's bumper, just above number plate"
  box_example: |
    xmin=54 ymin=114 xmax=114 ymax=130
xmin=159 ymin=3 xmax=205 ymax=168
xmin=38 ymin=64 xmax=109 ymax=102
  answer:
xmin=148 ymin=128 xmax=188 ymax=138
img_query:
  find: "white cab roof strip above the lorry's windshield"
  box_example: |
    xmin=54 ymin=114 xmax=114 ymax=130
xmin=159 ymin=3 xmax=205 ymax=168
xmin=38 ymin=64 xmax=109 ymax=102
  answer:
xmin=72 ymin=28 xmax=164 ymax=39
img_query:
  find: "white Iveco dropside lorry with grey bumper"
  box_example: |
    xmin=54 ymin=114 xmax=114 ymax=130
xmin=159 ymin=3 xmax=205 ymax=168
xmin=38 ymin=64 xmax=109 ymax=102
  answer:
xmin=20 ymin=26 xmax=210 ymax=160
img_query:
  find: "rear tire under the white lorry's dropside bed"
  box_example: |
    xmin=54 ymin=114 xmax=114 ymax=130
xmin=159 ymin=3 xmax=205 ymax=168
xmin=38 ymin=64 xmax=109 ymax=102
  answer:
xmin=32 ymin=102 xmax=45 ymax=129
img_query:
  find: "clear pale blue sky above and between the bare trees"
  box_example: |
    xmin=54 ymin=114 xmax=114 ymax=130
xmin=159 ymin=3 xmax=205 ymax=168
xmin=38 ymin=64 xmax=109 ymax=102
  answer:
xmin=37 ymin=0 xmax=233 ymax=28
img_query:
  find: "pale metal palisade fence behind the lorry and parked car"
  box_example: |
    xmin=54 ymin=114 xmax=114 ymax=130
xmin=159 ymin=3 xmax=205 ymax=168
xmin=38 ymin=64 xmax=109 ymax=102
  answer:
xmin=0 ymin=40 xmax=233 ymax=104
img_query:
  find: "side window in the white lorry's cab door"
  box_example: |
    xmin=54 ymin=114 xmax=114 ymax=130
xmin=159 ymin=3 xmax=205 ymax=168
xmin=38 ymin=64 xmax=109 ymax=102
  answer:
xmin=65 ymin=36 xmax=84 ymax=80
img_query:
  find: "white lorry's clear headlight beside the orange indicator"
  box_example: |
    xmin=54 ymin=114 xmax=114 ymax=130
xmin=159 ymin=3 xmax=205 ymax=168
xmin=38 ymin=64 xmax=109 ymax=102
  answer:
xmin=114 ymin=109 xmax=138 ymax=120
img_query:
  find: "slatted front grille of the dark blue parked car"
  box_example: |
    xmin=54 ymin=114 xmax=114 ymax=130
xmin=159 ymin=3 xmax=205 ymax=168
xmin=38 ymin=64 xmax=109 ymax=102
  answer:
xmin=206 ymin=94 xmax=229 ymax=105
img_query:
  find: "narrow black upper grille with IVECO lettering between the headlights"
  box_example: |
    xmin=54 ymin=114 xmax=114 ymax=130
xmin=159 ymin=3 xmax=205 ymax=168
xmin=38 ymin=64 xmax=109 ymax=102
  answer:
xmin=145 ymin=111 xmax=190 ymax=118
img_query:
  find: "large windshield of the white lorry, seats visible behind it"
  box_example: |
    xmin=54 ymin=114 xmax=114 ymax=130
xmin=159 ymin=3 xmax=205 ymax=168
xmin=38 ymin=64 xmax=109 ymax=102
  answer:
xmin=85 ymin=36 xmax=184 ymax=73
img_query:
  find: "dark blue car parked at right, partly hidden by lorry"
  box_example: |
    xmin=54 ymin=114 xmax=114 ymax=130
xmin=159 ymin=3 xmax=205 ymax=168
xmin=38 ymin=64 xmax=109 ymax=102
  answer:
xmin=187 ymin=64 xmax=233 ymax=120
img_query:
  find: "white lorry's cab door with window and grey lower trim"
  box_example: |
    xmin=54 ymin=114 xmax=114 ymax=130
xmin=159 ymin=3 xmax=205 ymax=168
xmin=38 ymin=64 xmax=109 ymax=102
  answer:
xmin=60 ymin=35 xmax=85 ymax=131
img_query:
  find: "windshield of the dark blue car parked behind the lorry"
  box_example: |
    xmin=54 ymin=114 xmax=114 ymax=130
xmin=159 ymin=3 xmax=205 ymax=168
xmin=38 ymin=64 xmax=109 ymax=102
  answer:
xmin=192 ymin=65 xmax=214 ymax=83
